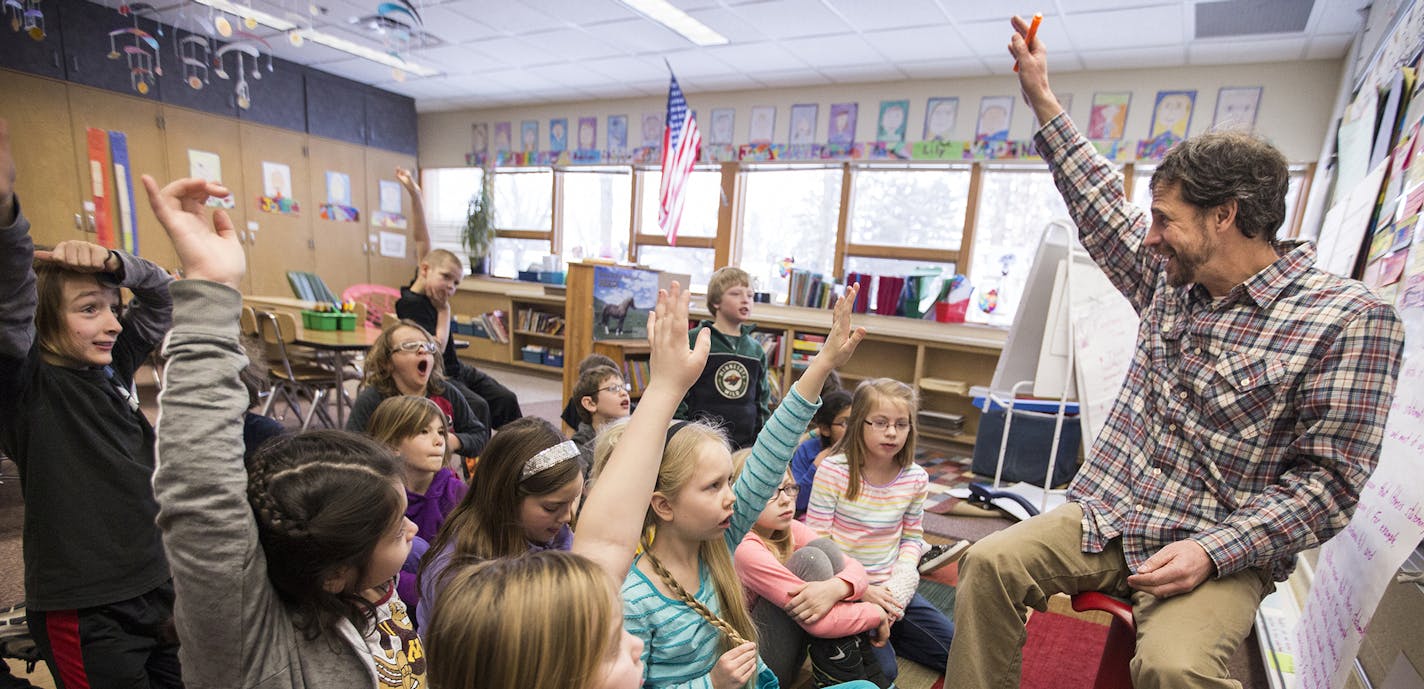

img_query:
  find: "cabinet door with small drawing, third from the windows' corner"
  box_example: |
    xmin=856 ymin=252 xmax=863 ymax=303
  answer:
xmin=239 ymin=124 xmax=319 ymax=296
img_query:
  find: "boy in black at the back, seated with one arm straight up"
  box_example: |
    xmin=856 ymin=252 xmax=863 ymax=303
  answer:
xmin=396 ymin=168 xmax=523 ymax=430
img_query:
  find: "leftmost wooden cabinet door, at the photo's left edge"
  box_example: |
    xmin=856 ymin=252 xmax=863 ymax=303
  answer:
xmin=0 ymin=69 xmax=85 ymax=246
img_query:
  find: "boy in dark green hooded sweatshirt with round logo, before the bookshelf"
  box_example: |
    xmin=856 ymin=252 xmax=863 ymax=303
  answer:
xmin=676 ymin=266 xmax=772 ymax=447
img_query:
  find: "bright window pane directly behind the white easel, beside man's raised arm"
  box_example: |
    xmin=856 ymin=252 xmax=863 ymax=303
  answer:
xmin=967 ymin=167 xmax=1068 ymax=326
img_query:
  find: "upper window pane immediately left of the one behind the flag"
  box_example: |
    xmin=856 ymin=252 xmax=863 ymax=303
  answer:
xmin=560 ymin=168 xmax=632 ymax=261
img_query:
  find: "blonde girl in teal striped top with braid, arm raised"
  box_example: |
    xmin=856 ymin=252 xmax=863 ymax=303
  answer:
xmin=615 ymin=281 xmax=864 ymax=689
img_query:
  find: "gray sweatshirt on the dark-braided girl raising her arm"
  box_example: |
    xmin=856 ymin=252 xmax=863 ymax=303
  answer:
xmin=154 ymin=280 xmax=376 ymax=689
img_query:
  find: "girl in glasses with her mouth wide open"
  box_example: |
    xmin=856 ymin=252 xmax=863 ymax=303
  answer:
xmin=346 ymin=320 xmax=490 ymax=477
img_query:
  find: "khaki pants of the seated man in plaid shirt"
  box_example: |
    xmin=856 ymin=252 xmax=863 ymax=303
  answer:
xmin=944 ymin=503 xmax=1270 ymax=689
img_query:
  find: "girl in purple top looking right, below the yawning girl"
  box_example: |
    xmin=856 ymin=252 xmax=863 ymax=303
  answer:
xmin=366 ymin=394 xmax=470 ymax=618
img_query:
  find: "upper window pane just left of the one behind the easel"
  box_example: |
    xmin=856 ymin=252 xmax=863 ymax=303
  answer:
xmin=849 ymin=167 xmax=970 ymax=251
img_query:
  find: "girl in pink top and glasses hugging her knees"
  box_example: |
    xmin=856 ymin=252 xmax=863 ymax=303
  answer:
xmin=733 ymin=458 xmax=890 ymax=686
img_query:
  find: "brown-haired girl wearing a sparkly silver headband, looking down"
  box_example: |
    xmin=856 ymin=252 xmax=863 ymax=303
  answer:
xmin=416 ymin=416 xmax=584 ymax=629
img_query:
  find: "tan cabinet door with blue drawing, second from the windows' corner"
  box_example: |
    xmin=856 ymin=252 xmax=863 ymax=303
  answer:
xmin=308 ymin=137 xmax=370 ymax=295
